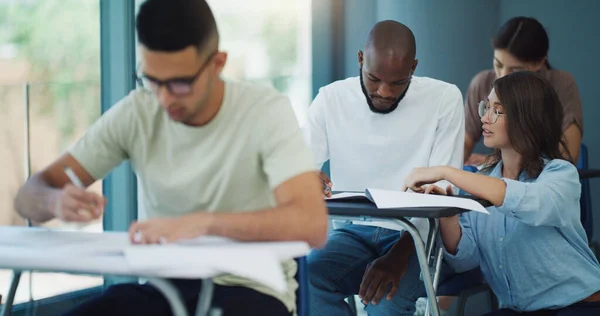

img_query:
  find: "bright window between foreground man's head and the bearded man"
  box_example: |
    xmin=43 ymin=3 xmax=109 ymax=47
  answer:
xmin=207 ymin=0 xmax=312 ymax=123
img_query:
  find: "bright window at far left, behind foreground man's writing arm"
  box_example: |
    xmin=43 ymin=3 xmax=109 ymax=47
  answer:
xmin=0 ymin=0 xmax=103 ymax=303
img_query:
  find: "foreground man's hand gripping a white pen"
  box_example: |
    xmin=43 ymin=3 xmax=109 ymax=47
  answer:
xmin=52 ymin=184 xmax=106 ymax=222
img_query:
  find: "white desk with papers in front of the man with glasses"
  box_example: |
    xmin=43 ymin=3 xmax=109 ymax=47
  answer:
xmin=0 ymin=227 xmax=310 ymax=316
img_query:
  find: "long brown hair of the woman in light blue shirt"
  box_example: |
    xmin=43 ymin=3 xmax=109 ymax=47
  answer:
xmin=484 ymin=71 xmax=570 ymax=178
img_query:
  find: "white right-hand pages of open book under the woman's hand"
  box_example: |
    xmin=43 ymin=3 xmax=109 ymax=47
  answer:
xmin=367 ymin=189 xmax=489 ymax=214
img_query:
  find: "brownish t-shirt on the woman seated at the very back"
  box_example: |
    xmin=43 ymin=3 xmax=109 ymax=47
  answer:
xmin=465 ymin=68 xmax=583 ymax=142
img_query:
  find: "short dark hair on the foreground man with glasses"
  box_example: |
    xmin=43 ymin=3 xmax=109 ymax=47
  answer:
xmin=136 ymin=0 xmax=218 ymax=52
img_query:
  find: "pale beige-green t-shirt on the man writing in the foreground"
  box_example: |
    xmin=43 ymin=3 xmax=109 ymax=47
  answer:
xmin=69 ymin=82 xmax=315 ymax=311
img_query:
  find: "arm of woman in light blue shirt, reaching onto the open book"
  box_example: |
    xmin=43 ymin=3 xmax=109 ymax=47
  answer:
xmin=403 ymin=159 xmax=581 ymax=227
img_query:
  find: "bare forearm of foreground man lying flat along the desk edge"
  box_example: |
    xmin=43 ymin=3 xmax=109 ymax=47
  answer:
xmin=198 ymin=203 xmax=327 ymax=248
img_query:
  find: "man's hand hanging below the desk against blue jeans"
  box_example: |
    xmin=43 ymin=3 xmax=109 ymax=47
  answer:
xmin=358 ymin=254 xmax=408 ymax=305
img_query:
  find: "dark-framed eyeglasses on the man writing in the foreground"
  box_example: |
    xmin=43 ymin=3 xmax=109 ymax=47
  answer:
xmin=134 ymin=51 xmax=217 ymax=96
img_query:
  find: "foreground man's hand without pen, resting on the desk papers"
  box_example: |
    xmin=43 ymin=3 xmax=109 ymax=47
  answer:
xmin=129 ymin=212 xmax=212 ymax=244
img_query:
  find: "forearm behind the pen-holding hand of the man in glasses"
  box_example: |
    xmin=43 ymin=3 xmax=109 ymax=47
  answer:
xmin=14 ymin=175 xmax=60 ymax=223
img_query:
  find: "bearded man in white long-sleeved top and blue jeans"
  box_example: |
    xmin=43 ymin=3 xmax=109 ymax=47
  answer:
xmin=303 ymin=21 xmax=464 ymax=316
